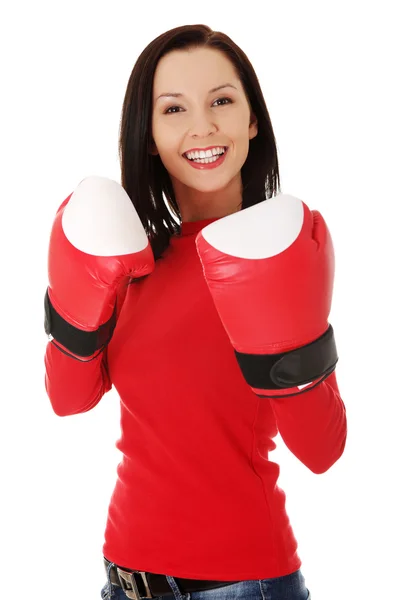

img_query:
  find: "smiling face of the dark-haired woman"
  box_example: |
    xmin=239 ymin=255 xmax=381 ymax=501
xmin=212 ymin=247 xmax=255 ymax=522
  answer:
xmin=152 ymin=48 xmax=257 ymax=200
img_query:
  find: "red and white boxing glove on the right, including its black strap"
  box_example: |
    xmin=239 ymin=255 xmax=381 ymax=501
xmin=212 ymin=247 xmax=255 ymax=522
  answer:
xmin=196 ymin=194 xmax=338 ymax=397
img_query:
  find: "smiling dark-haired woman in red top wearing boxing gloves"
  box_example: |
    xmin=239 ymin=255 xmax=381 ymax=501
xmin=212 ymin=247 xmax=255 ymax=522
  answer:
xmin=45 ymin=25 xmax=346 ymax=600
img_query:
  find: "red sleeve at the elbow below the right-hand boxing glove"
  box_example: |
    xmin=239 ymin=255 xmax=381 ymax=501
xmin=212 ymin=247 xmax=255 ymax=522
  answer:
xmin=269 ymin=371 xmax=347 ymax=474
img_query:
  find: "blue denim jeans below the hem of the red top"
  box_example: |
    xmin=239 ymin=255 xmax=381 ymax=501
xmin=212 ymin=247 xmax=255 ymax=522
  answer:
xmin=101 ymin=563 xmax=311 ymax=600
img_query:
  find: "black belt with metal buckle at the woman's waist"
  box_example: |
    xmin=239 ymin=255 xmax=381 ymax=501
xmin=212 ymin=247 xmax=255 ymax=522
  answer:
xmin=104 ymin=557 xmax=238 ymax=600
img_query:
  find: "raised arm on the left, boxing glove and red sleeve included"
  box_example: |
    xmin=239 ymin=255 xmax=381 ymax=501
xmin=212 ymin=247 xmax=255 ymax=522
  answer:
xmin=45 ymin=176 xmax=154 ymax=416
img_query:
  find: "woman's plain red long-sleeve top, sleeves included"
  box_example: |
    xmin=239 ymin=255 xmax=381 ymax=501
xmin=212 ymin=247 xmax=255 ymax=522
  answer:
xmin=45 ymin=219 xmax=347 ymax=581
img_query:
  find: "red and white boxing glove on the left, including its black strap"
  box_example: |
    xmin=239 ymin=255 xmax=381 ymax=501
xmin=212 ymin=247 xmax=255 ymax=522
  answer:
xmin=45 ymin=176 xmax=154 ymax=361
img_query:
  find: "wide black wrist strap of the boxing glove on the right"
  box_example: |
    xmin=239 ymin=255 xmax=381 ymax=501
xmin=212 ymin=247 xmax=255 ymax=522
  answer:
xmin=235 ymin=325 xmax=338 ymax=390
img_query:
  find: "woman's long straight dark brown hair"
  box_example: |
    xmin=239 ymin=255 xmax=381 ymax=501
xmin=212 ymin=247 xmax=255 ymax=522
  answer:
xmin=119 ymin=25 xmax=280 ymax=283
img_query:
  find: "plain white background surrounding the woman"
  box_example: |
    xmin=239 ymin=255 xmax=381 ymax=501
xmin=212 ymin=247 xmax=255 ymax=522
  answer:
xmin=0 ymin=0 xmax=400 ymax=600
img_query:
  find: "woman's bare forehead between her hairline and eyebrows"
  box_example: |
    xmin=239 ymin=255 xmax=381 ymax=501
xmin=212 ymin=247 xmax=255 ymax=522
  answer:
xmin=153 ymin=48 xmax=242 ymax=97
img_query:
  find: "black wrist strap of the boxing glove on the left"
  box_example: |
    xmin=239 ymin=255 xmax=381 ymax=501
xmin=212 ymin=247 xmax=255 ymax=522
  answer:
xmin=44 ymin=290 xmax=117 ymax=360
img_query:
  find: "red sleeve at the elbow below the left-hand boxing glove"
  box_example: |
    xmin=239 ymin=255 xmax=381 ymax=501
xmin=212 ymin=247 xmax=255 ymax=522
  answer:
xmin=44 ymin=281 xmax=128 ymax=417
